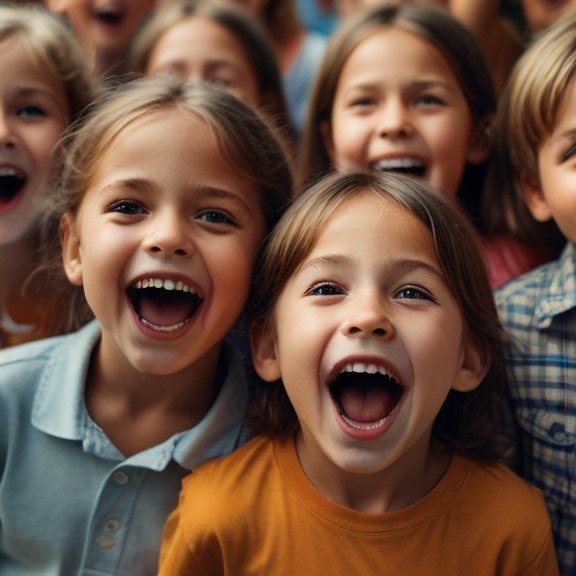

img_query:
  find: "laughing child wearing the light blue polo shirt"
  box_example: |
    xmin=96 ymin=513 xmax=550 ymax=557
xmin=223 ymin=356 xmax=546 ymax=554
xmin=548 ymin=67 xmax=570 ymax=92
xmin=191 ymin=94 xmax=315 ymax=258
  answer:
xmin=0 ymin=78 xmax=291 ymax=576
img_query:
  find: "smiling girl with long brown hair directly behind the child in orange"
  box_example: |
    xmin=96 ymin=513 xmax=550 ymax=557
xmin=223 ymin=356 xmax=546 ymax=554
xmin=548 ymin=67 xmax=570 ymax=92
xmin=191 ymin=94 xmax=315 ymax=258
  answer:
xmin=301 ymin=3 xmax=544 ymax=290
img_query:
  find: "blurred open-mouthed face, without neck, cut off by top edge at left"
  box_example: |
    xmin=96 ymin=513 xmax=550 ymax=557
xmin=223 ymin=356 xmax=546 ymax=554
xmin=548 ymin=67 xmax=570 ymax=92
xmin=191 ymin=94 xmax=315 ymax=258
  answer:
xmin=45 ymin=0 xmax=155 ymax=56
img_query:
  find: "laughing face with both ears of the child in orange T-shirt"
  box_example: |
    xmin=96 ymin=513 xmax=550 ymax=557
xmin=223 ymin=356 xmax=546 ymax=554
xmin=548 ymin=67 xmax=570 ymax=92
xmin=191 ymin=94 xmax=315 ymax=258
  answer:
xmin=253 ymin=192 xmax=481 ymax=502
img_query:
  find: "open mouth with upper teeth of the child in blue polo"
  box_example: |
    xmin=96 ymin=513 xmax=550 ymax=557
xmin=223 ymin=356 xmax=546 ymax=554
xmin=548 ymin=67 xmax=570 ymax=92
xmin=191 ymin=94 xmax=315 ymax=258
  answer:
xmin=127 ymin=278 xmax=203 ymax=332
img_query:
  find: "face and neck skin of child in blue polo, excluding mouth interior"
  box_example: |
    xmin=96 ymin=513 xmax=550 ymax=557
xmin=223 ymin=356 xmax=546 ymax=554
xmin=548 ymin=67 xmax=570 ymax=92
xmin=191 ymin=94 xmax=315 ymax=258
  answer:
xmin=62 ymin=109 xmax=265 ymax=453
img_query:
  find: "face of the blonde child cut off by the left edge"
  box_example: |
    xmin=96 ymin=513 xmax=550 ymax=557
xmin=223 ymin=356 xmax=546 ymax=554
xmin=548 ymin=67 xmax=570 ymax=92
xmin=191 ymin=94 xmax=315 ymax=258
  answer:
xmin=0 ymin=39 xmax=68 ymax=244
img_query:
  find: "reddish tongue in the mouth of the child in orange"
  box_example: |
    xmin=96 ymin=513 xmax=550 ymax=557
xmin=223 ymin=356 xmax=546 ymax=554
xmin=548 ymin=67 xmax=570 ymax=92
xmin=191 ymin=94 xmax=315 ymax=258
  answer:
xmin=339 ymin=386 xmax=394 ymax=424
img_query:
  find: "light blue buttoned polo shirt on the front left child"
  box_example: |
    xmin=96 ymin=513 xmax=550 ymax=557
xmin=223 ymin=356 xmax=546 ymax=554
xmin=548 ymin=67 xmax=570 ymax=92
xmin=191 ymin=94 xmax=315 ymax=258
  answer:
xmin=0 ymin=321 xmax=249 ymax=576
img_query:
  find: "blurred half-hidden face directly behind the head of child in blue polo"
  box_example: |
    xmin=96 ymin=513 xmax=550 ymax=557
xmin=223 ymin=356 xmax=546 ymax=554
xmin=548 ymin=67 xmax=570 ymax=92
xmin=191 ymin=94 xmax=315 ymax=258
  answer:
xmin=146 ymin=16 xmax=261 ymax=107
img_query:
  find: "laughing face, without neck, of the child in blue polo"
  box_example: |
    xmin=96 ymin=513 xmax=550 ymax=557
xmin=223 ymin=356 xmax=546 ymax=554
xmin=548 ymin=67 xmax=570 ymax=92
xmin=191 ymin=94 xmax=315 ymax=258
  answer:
xmin=62 ymin=109 xmax=266 ymax=374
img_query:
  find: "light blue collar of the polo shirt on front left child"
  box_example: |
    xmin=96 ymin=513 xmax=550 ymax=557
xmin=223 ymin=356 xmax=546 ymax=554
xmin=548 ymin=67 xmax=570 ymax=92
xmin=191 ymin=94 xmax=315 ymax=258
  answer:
xmin=32 ymin=321 xmax=249 ymax=470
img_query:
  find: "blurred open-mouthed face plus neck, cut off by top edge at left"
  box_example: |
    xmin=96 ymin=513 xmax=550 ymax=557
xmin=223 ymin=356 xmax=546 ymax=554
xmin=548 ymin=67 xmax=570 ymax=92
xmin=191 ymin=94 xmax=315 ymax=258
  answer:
xmin=43 ymin=0 xmax=155 ymax=80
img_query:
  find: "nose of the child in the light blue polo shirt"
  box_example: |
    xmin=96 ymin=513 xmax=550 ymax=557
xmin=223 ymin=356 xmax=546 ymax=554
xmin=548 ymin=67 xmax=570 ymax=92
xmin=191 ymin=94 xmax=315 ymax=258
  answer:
xmin=142 ymin=210 xmax=195 ymax=257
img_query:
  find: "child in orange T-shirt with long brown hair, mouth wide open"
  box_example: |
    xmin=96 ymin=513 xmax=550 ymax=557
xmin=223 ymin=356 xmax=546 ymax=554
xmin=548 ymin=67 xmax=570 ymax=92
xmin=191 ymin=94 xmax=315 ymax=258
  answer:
xmin=160 ymin=169 xmax=557 ymax=576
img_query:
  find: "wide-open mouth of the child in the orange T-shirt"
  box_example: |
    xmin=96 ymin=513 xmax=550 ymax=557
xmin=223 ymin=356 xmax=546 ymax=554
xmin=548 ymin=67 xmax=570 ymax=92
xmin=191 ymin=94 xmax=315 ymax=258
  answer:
xmin=330 ymin=362 xmax=404 ymax=430
